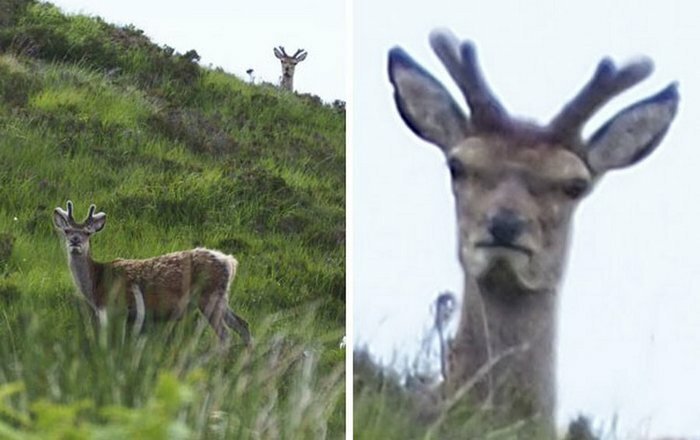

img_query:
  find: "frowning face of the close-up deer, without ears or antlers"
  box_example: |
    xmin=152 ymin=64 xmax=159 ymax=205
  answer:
xmin=447 ymin=136 xmax=592 ymax=289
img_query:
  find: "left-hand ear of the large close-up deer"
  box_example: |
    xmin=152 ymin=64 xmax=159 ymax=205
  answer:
xmin=389 ymin=47 xmax=469 ymax=151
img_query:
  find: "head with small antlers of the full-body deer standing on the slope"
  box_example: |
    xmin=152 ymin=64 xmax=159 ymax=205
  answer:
xmin=53 ymin=200 xmax=107 ymax=255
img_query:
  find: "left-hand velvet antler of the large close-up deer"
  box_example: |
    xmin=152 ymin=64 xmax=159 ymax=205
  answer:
xmin=430 ymin=30 xmax=508 ymax=130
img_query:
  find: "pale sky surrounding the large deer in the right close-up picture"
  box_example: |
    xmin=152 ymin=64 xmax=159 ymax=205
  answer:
xmin=358 ymin=0 xmax=700 ymax=438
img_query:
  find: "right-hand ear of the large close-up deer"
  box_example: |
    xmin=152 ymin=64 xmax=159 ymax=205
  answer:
xmin=587 ymin=83 xmax=679 ymax=174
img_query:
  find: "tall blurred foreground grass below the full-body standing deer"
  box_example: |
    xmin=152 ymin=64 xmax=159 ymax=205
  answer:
xmin=0 ymin=308 xmax=344 ymax=439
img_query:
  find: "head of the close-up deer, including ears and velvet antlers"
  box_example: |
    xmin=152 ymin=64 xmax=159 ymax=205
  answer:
xmin=389 ymin=31 xmax=679 ymax=291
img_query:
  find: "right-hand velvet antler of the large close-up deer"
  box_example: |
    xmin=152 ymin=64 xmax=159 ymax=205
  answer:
xmin=549 ymin=58 xmax=654 ymax=139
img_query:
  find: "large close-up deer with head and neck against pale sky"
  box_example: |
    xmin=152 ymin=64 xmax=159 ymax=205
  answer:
xmin=388 ymin=30 xmax=679 ymax=437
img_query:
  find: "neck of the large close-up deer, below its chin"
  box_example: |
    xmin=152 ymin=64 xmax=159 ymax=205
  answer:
xmin=450 ymin=265 xmax=557 ymax=423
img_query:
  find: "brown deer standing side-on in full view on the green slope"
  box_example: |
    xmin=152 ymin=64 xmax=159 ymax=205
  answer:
xmin=53 ymin=200 xmax=252 ymax=346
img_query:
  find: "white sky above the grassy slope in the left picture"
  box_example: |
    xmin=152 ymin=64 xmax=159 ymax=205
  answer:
xmin=51 ymin=0 xmax=346 ymax=102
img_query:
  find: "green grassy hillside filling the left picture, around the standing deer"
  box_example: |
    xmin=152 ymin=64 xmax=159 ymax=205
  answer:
xmin=0 ymin=0 xmax=345 ymax=438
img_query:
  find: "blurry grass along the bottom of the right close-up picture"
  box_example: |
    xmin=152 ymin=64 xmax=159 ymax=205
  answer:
xmin=353 ymin=354 xmax=596 ymax=440
